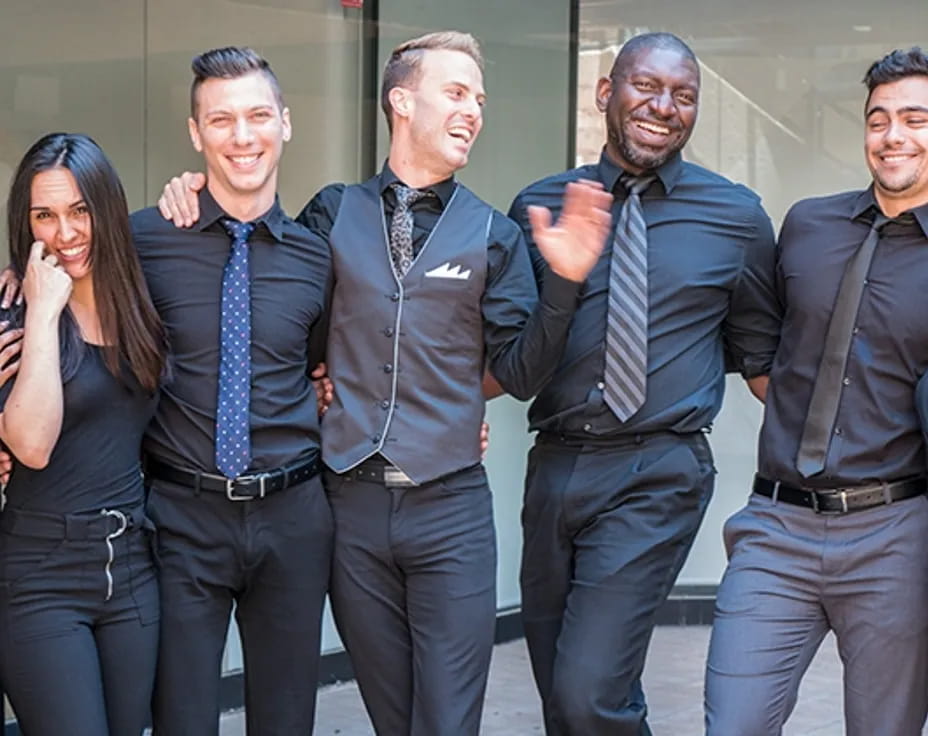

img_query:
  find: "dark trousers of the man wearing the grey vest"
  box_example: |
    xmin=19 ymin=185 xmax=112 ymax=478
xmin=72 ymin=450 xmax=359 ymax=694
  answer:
xmin=326 ymin=465 xmax=496 ymax=736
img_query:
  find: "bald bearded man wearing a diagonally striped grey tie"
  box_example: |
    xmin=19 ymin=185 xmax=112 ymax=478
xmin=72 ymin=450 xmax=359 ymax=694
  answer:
xmin=500 ymin=33 xmax=780 ymax=736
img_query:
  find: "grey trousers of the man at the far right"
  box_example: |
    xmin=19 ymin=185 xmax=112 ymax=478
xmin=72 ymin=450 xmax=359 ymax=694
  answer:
xmin=706 ymin=494 xmax=928 ymax=736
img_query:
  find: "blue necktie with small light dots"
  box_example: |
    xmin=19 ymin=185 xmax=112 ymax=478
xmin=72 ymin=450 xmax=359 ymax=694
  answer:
xmin=216 ymin=218 xmax=255 ymax=478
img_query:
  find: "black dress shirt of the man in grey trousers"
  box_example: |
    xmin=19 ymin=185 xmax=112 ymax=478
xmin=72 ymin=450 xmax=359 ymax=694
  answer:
xmin=759 ymin=189 xmax=928 ymax=488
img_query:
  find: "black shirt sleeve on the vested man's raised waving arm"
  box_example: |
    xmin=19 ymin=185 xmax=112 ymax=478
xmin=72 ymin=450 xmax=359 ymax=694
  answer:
xmin=483 ymin=207 xmax=580 ymax=400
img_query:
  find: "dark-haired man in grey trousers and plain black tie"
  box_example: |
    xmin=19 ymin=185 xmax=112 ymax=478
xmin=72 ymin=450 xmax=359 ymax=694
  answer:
xmin=706 ymin=48 xmax=928 ymax=736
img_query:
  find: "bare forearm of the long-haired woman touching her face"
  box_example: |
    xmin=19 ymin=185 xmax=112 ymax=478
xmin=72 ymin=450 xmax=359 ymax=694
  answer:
xmin=0 ymin=312 xmax=64 ymax=468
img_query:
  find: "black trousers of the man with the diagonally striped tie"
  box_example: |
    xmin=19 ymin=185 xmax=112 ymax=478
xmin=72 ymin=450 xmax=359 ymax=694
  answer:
xmin=521 ymin=433 xmax=715 ymax=736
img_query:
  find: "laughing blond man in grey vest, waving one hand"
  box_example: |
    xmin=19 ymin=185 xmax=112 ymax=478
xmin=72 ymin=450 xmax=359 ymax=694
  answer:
xmin=162 ymin=25 xmax=612 ymax=736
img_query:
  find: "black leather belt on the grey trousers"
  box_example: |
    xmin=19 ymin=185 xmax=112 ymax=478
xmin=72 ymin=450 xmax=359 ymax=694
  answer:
xmin=754 ymin=475 xmax=928 ymax=514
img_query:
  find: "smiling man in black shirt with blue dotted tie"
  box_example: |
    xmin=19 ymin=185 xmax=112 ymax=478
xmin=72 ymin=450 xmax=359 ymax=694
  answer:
xmin=132 ymin=48 xmax=332 ymax=736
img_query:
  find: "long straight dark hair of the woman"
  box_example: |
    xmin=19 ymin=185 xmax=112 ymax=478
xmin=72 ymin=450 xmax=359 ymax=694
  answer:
xmin=7 ymin=133 xmax=165 ymax=393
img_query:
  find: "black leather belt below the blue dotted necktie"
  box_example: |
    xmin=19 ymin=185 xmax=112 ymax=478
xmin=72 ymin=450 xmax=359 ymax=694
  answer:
xmin=145 ymin=454 xmax=320 ymax=501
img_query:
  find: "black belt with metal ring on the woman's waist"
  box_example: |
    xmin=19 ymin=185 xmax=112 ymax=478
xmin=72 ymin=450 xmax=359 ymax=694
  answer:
xmin=0 ymin=506 xmax=148 ymax=540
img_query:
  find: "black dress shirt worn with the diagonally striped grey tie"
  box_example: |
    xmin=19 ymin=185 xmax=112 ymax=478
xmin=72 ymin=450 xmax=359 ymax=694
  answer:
xmin=509 ymin=152 xmax=780 ymax=440
